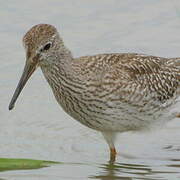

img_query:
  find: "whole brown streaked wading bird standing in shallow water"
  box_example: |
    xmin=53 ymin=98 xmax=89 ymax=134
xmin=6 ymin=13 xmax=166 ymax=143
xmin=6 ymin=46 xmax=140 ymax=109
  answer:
xmin=9 ymin=24 xmax=180 ymax=161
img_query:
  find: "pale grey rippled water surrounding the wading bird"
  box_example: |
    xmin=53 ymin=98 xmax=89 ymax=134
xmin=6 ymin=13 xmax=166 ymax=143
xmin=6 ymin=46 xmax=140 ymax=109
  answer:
xmin=0 ymin=0 xmax=180 ymax=180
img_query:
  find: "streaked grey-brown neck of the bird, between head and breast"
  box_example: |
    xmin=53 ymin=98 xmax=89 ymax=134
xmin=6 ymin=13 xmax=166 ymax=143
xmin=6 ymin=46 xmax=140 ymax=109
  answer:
xmin=41 ymin=45 xmax=82 ymax=99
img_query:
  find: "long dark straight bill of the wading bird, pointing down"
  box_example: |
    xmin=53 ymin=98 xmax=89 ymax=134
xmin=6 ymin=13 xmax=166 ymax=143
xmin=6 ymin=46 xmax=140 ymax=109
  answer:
xmin=9 ymin=61 xmax=37 ymax=110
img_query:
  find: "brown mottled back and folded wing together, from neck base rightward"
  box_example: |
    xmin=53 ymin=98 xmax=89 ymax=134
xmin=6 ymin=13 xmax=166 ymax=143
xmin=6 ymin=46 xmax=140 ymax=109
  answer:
xmin=73 ymin=53 xmax=180 ymax=104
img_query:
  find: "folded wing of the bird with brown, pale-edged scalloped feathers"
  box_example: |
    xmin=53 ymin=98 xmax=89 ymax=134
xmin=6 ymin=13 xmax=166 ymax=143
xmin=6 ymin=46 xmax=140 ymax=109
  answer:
xmin=97 ymin=54 xmax=179 ymax=103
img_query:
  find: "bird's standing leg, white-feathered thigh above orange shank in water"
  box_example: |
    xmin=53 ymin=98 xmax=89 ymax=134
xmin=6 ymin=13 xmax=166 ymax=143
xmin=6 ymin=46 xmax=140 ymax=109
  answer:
xmin=102 ymin=131 xmax=117 ymax=163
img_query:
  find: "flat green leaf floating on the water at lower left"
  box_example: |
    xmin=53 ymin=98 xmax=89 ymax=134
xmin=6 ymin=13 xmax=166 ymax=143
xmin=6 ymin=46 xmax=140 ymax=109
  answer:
xmin=0 ymin=158 xmax=60 ymax=171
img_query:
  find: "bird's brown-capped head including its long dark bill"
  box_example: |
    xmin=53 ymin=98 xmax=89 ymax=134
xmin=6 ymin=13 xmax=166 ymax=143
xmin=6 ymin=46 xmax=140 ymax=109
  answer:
xmin=9 ymin=24 xmax=63 ymax=110
